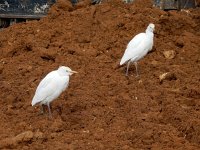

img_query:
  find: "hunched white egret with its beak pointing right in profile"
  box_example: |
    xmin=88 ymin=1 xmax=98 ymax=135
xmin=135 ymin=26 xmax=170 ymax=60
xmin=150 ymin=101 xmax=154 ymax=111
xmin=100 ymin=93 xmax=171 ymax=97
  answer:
xmin=32 ymin=66 xmax=77 ymax=117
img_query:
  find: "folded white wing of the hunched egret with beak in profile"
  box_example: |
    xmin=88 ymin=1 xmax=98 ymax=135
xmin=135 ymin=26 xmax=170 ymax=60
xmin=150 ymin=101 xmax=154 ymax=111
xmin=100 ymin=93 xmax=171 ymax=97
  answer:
xmin=32 ymin=72 xmax=56 ymax=106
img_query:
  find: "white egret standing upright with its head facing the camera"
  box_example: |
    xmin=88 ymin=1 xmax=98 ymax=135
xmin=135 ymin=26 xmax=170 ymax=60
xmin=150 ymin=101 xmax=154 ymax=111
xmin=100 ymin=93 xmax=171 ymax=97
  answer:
xmin=120 ymin=23 xmax=155 ymax=76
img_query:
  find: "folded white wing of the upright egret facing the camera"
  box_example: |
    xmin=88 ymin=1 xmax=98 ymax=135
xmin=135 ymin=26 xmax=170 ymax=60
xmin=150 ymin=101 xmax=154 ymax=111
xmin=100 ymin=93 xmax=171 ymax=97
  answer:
xmin=120 ymin=33 xmax=145 ymax=65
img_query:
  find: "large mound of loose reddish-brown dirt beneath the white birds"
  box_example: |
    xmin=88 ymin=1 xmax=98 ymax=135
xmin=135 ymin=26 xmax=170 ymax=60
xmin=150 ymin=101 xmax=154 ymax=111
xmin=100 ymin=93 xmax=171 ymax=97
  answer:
xmin=0 ymin=0 xmax=200 ymax=150
